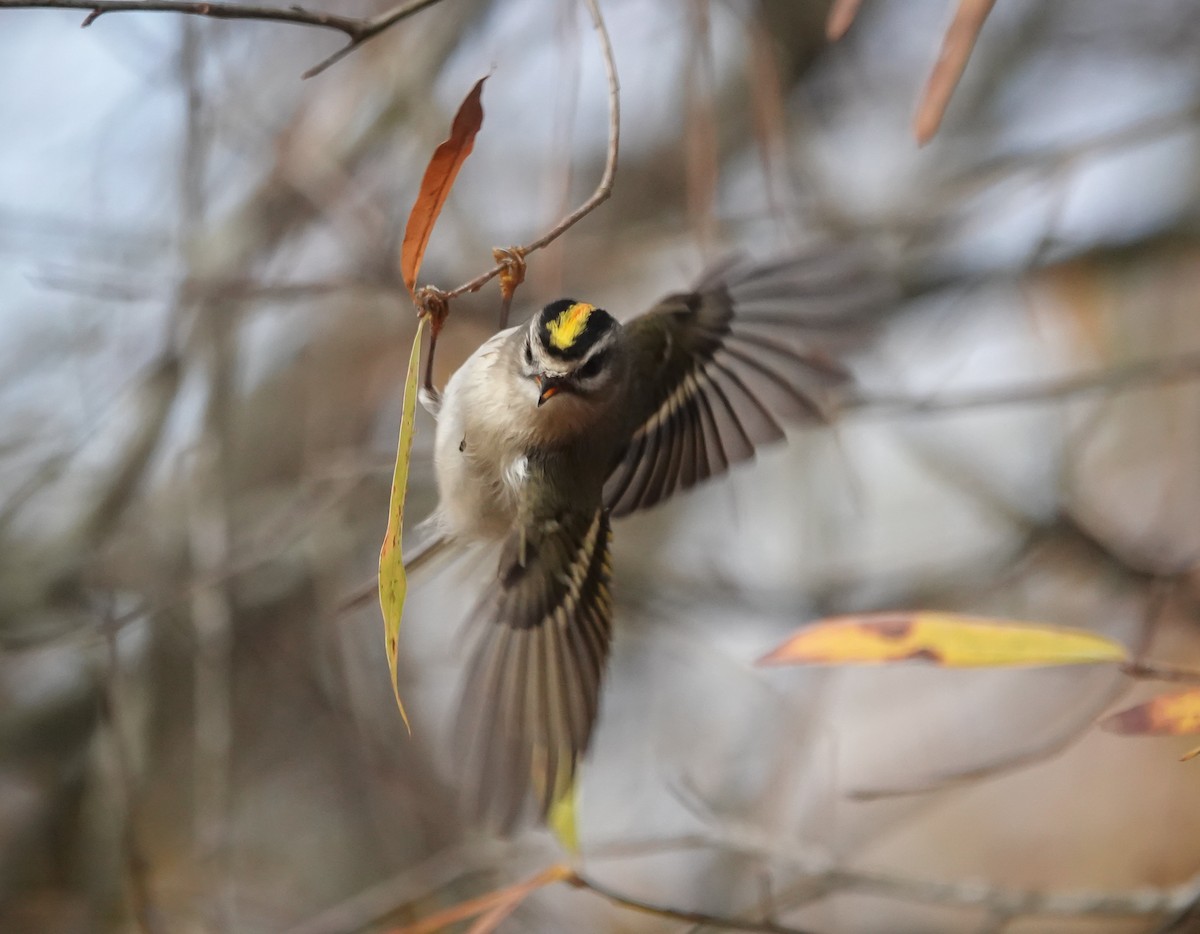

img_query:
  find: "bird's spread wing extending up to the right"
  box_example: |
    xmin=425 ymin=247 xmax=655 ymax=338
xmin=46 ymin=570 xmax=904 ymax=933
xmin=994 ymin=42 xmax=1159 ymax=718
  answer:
xmin=604 ymin=251 xmax=892 ymax=516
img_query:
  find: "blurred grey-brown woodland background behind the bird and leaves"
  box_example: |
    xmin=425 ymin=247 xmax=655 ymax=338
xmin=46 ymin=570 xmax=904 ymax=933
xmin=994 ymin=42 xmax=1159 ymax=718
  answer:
xmin=7 ymin=0 xmax=1200 ymax=934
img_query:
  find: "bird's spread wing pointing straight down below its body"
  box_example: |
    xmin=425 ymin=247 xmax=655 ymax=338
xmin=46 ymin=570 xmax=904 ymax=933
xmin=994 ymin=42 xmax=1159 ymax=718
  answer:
xmin=458 ymin=507 xmax=612 ymax=830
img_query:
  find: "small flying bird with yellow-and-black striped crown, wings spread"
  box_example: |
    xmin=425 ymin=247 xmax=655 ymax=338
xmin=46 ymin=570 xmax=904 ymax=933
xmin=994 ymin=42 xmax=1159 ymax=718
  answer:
xmin=406 ymin=249 xmax=890 ymax=832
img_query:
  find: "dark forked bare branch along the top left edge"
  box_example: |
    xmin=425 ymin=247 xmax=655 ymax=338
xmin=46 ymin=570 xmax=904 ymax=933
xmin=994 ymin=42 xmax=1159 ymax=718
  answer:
xmin=0 ymin=0 xmax=438 ymax=78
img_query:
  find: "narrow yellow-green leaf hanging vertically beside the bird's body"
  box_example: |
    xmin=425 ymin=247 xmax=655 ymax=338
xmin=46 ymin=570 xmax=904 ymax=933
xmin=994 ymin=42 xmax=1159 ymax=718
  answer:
xmin=379 ymin=318 xmax=425 ymax=732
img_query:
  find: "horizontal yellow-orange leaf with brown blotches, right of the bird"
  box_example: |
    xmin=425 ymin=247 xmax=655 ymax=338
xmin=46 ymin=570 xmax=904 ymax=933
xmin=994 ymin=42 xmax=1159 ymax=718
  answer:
xmin=758 ymin=612 xmax=1128 ymax=667
